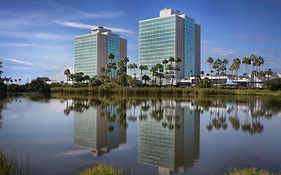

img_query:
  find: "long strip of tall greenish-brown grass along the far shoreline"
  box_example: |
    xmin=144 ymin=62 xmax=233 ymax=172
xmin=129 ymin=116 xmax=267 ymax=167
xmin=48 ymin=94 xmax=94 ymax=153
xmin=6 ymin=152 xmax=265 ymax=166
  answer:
xmin=51 ymin=87 xmax=281 ymax=97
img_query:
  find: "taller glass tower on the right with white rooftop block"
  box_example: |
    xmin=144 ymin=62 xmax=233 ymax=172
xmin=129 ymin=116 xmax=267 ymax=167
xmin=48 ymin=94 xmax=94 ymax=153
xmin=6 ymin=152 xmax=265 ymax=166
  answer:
xmin=139 ymin=9 xmax=201 ymax=79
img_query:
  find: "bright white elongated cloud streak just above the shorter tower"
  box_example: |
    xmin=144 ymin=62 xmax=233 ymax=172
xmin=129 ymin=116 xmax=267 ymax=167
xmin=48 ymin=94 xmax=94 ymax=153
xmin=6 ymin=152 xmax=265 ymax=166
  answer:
xmin=54 ymin=21 xmax=135 ymax=35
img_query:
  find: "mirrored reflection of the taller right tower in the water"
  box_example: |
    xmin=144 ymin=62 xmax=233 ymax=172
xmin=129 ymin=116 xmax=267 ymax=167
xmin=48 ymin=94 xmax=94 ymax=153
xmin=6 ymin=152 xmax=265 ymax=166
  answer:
xmin=138 ymin=101 xmax=200 ymax=174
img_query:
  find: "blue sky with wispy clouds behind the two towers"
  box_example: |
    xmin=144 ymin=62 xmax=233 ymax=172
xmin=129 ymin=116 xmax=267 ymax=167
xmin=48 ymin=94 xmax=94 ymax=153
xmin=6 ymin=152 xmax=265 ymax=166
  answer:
xmin=0 ymin=0 xmax=281 ymax=82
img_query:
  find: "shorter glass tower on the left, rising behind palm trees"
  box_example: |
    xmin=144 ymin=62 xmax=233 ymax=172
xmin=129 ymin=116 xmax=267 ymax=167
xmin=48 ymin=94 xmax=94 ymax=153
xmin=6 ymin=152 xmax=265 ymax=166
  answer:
xmin=74 ymin=27 xmax=127 ymax=77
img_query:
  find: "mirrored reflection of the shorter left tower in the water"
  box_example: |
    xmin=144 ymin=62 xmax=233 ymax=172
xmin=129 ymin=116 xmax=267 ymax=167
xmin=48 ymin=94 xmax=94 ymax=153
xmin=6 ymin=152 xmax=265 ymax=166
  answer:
xmin=74 ymin=105 xmax=126 ymax=156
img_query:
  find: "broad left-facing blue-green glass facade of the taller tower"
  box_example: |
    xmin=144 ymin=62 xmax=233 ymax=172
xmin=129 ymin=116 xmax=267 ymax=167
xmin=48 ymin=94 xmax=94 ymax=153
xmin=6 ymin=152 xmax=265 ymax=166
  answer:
xmin=139 ymin=16 xmax=176 ymax=75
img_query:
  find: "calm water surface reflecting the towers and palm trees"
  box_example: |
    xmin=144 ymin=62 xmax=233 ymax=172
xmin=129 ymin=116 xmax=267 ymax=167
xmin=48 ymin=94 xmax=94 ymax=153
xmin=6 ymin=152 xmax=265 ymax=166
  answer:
xmin=0 ymin=96 xmax=281 ymax=175
